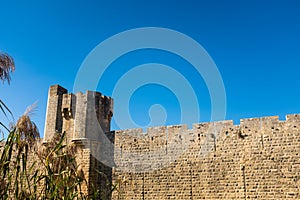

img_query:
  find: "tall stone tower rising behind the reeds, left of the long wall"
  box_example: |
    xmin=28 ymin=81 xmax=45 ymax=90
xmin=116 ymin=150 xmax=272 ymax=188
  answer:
xmin=43 ymin=85 xmax=113 ymax=199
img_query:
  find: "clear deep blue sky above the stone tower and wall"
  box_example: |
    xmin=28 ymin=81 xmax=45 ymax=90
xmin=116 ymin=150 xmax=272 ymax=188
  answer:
xmin=0 ymin=0 xmax=300 ymax=134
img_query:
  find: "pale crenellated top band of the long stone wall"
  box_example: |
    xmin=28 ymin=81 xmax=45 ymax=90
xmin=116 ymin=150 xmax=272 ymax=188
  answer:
xmin=115 ymin=114 xmax=300 ymax=145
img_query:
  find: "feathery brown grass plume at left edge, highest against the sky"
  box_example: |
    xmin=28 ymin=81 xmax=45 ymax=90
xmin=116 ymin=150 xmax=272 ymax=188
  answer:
xmin=0 ymin=52 xmax=15 ymax=84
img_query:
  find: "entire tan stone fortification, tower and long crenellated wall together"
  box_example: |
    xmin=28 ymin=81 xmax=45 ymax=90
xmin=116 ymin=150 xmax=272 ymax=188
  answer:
xmin=44 ymin=85 xmax=300 ymax=200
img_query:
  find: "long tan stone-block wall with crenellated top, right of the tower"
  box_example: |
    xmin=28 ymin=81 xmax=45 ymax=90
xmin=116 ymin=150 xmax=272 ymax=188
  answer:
xmin=113 ymin=115 xmax=300 ymax=200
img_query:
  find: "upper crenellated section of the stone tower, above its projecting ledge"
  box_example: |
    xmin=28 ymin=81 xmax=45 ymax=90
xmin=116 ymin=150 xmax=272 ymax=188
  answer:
xmin=44 ymin=85 xmax=113 ymax=141
